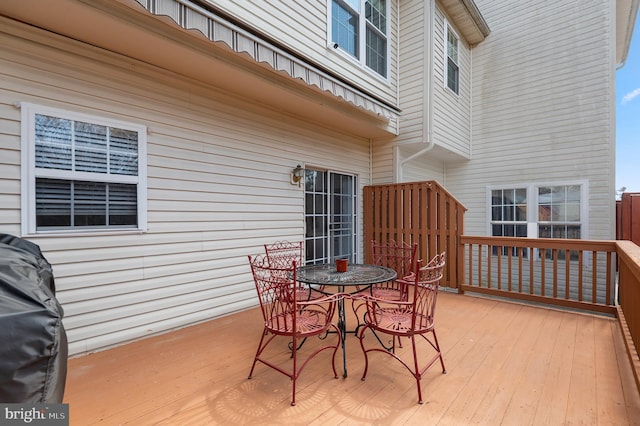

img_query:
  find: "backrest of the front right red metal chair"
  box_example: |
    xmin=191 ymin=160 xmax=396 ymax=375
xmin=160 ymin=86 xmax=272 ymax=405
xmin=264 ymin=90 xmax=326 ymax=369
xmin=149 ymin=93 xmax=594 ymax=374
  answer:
xmin=412 ymin=252 xmax=446 ymax=331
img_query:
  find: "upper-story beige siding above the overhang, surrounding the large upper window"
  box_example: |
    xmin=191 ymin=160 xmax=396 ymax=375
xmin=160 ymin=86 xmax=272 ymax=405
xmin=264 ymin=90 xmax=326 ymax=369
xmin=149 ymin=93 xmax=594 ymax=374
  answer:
xmin=206 ymin=0 xmax=400 ymax=106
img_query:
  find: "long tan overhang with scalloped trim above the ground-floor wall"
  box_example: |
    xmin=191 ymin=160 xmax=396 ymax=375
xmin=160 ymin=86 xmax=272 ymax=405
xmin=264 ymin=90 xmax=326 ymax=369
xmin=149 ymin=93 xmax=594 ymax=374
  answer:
xmin=0 ymin=0 xmax=398 ymax=138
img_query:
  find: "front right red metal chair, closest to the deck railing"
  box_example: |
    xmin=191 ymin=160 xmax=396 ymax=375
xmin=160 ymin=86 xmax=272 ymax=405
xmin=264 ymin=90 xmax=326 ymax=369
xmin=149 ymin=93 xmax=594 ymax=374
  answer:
xmin=359 ymin=252 xmax=447 ymax=404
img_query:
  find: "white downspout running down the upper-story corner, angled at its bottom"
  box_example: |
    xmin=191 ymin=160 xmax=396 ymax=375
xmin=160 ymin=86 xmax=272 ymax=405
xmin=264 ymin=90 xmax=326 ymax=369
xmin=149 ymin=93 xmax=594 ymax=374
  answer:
xmin=396 ymin=0 xmax=435 ymax=182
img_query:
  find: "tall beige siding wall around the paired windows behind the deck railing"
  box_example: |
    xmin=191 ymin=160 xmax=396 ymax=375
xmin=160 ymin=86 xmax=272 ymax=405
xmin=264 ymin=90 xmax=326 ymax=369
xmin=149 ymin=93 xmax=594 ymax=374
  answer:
xmin=447 ymin=0 xmax=615 ymax=239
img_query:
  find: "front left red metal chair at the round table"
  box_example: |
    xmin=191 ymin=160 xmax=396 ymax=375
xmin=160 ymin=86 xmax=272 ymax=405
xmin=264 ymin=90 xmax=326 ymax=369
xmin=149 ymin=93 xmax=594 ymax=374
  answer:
xmin=249 ymin=255 xmax=342 ymax=405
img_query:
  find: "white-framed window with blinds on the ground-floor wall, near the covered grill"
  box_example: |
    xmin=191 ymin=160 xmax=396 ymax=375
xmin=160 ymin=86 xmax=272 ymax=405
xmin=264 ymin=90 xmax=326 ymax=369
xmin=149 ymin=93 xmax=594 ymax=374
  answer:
xmin=22 ymin=104 xmax=146 ymax=234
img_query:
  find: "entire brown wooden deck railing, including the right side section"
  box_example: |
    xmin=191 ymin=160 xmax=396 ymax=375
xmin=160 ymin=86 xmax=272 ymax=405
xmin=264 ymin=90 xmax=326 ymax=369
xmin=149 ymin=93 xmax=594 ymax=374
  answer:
xmin=458 ymin=235 xmax=640 ymax=389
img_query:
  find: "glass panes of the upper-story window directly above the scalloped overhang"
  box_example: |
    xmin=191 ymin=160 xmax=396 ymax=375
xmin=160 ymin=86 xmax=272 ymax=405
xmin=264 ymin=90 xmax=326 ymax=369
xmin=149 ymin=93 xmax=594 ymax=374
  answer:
xmin=330 ymin=0 xmax=389 ymax=78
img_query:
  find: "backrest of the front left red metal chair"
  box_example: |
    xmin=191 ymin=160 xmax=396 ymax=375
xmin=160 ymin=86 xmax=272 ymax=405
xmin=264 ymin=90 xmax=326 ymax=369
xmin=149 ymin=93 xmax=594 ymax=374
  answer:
xmin=249 ymin=255 xmax=297 ymax=333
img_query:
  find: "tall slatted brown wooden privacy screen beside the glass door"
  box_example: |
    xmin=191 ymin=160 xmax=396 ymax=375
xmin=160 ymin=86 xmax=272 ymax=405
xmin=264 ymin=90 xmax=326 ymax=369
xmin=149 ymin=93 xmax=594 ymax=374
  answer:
xmin=364 ymin=181 xmax=467 ymax=287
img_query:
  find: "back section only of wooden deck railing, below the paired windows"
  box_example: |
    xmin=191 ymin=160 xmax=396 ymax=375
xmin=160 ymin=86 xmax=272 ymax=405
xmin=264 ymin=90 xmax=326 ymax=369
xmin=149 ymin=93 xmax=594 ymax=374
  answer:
xmin=460 ymin=236 xmax=616 ymax=315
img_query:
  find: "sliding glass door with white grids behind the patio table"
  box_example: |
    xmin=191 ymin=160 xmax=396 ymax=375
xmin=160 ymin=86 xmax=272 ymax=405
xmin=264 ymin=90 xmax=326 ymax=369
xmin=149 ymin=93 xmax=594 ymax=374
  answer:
xmin=305 ymin=169 xmax=357 ymax=264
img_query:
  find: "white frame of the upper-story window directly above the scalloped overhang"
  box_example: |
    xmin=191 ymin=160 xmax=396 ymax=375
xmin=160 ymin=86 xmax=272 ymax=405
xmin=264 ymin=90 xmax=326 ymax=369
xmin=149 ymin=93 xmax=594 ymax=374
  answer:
xmin=327 ymin=0 xmax=393 ymax=83
